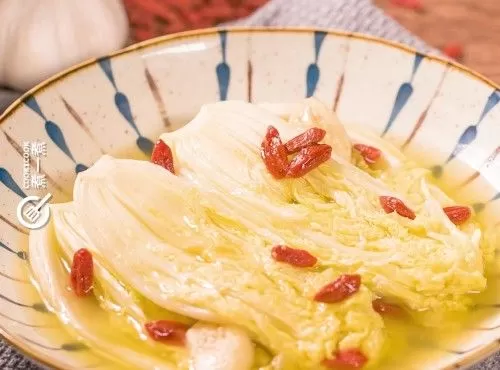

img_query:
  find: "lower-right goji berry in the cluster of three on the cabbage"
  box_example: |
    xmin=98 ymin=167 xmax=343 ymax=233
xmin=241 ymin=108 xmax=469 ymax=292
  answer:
xmin=286 ymin=144 xmax=332 ymax=178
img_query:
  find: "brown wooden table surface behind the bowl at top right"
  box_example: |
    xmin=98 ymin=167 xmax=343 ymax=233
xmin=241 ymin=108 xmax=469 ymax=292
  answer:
xmin=374 ymin=0 xmax=500 ymax=84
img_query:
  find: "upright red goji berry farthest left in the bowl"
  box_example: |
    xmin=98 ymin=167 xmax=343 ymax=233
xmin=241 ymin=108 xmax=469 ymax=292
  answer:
xmin=70 ymin=248 xmax=94 ymax=297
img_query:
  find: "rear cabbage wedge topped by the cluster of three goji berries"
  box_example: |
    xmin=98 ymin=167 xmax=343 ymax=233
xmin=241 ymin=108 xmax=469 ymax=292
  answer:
xmin=161 ymin=99 xmax=486 ymax=310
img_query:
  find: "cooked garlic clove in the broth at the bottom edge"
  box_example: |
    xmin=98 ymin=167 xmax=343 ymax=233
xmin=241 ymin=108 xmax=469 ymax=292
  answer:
xmin=186 ymin=323 xmax=254 ymax=370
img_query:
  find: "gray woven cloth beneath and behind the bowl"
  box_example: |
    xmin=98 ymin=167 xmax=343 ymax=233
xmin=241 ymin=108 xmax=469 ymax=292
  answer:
xmin=0 ymin=0 xmax=500 ymax=370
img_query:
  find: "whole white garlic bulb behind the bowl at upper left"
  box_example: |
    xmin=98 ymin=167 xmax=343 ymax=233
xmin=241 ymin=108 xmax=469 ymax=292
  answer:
xmin=0 ymin=0 xmax=129 ymax=90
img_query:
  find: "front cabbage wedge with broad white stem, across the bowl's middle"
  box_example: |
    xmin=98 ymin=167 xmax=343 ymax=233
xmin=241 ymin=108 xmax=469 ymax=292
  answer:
xmin=70 ymin=156 xmax=384 ymax=369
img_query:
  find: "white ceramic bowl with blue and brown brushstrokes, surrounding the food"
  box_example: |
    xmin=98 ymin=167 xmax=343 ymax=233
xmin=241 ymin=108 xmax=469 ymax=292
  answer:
xmin=0 ymin=28 xmax=500 ymax=369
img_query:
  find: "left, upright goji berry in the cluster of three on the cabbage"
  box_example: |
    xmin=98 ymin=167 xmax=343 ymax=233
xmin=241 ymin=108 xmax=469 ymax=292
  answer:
xmin=261 ymin=126 xmax=288 ymax=179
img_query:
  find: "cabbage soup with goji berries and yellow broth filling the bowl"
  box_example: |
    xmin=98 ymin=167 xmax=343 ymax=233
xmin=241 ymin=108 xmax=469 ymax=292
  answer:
xmin=30 ymin=99 xmax=497 ymax=370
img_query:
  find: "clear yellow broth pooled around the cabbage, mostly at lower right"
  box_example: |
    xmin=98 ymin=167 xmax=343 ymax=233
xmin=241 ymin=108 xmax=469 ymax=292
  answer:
xmin=24 ymin=139 xmax=500 ymax=370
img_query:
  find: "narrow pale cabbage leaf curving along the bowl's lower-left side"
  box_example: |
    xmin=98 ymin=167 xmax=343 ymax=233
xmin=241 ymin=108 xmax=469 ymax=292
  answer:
xmin=29 ymin=222 xmax=187 ymax=370
